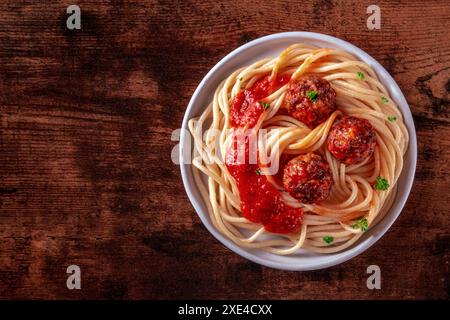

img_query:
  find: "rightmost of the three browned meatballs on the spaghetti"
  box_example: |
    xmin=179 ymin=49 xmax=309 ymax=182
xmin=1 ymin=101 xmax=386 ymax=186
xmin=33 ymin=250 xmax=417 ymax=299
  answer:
xmin=327 ymin=116 xmax=377 ymax=164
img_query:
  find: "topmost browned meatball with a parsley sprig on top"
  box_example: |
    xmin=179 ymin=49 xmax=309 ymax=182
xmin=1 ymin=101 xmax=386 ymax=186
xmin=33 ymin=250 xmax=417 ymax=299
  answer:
xmin=284 ymin=75 xmax=336 ymax=129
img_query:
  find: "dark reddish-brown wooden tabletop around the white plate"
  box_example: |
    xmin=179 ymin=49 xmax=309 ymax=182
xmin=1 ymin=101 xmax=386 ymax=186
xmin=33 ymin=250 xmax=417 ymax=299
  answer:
xmin=0 ymin=0 xmax=450 ymax=299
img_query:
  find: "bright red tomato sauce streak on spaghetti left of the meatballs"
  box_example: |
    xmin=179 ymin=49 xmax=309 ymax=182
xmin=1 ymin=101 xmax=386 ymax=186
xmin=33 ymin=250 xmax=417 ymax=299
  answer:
xmin=226 ymin=76 xmax=303 ymax=233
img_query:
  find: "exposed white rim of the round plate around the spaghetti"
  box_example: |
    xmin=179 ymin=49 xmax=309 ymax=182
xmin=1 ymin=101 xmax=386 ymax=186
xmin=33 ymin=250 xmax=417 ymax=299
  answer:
xmin=180 ymin=32 xmax=417 ymax=271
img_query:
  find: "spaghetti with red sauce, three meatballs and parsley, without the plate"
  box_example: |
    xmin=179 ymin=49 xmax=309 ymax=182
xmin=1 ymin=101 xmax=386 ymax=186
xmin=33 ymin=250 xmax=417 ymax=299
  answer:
xmin=189 ymin=44 xmax=408 ymax=255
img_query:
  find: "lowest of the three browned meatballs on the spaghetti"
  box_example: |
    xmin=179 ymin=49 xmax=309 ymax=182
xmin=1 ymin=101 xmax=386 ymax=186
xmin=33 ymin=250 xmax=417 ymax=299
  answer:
xmin=283 ymin=152 xmax=333 ymax=203
